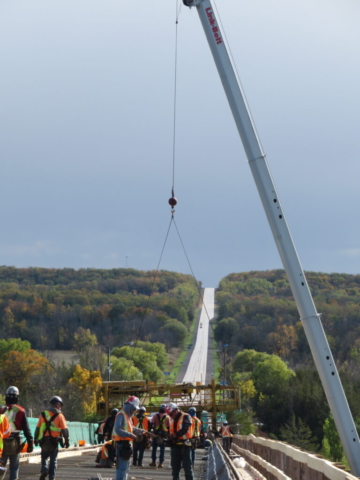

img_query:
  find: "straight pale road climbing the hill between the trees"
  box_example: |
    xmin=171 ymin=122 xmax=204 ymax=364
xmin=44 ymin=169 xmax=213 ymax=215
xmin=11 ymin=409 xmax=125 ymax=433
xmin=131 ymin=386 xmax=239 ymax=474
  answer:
xmin=183 ymin=288 xmax=215 ymax=384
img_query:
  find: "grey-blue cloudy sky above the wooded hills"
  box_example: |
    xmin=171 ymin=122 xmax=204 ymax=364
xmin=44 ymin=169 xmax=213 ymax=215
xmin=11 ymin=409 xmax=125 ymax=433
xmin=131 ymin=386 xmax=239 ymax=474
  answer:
xmin=0 ymin=0 xmax=360 ymax=287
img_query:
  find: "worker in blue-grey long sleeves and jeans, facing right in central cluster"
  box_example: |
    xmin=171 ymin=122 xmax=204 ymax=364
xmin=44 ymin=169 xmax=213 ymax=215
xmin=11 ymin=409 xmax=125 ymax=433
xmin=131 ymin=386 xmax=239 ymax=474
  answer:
xmin=113 ymin=396 xmax=145 ymax=480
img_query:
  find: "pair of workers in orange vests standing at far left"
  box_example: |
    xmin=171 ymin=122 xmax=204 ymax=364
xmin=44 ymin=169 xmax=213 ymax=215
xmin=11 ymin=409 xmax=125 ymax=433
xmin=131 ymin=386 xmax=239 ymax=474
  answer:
xmin=0 ymin=386 xmax=69 ymax=480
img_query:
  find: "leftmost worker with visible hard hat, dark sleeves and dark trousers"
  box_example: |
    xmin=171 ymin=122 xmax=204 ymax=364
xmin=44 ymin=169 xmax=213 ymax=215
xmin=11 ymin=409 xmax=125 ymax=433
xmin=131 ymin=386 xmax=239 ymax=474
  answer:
xmin=2 ymin=386 xmax=34 ymax=480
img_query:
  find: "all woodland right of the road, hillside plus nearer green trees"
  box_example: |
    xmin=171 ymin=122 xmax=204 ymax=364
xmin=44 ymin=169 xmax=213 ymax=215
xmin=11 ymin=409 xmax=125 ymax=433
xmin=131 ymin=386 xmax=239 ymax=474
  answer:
xmin=215 ymin=270 xmax=360 ymax=460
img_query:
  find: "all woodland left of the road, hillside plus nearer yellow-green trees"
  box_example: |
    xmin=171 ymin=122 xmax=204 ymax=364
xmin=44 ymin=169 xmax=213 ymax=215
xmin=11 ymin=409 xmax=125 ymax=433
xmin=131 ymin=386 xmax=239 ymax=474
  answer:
xmin=0 ymin=267 xmax=199 ymax=421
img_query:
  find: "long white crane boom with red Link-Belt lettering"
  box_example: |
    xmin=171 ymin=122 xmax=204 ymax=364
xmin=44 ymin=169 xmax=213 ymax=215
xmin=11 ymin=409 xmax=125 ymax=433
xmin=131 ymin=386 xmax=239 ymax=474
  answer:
xmin=183 ymin=0 xmax=360 ymax=476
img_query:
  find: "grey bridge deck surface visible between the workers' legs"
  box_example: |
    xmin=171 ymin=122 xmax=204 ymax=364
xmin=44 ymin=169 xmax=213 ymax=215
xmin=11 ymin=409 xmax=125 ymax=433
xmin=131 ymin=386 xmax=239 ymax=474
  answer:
xmin=16 ymin=448 xmax=206 ymax=480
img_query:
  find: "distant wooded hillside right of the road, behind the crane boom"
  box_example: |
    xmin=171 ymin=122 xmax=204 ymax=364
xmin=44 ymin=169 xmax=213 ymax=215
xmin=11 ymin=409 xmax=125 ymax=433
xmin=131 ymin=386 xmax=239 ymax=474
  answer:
xmin=216 ymin=270 xmax=360 ymax=365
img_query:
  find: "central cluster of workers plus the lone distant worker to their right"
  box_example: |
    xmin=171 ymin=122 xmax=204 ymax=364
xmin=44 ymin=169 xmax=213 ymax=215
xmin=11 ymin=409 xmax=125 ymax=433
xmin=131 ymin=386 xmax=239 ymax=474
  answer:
xmin=97 ymin=396 xmax=233 ymax=480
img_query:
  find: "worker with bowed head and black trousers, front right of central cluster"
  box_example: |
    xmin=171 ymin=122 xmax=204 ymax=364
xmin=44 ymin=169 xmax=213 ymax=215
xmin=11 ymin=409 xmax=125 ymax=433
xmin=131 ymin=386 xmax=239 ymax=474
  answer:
xmin=166 ymin=402 xmax=194 ymax=480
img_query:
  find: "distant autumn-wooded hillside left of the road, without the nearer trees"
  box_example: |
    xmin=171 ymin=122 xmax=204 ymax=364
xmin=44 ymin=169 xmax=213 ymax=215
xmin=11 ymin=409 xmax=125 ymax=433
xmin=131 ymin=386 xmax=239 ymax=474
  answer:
xmin=0 ymin=267 xmax=199 ymax=351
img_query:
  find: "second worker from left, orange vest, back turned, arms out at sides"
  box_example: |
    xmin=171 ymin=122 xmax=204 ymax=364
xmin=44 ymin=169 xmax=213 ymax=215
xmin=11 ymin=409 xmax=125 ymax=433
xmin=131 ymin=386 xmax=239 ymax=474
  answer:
xmin=34 ymin=396 xmax=70 ymax=480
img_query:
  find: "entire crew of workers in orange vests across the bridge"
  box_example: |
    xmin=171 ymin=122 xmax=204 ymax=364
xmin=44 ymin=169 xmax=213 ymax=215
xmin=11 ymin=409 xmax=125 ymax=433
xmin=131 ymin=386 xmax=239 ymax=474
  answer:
xmin=0 ymin=386 xmax=233 ymax=480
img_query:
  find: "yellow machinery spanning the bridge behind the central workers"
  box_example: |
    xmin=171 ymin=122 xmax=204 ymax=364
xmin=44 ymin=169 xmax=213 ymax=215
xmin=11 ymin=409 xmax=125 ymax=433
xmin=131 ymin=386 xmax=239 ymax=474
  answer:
xmin=97 ymin=380 xmax=241 ymax=425
